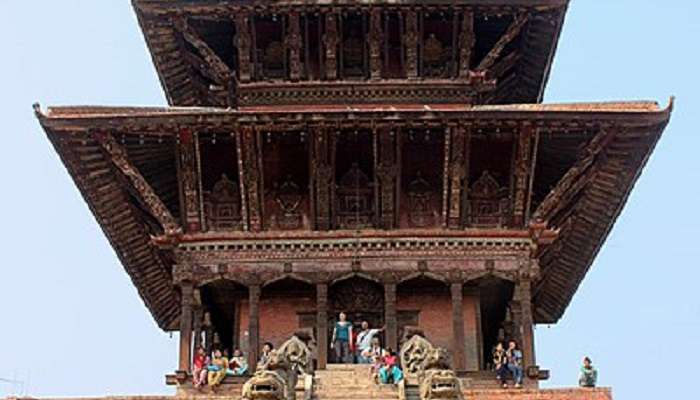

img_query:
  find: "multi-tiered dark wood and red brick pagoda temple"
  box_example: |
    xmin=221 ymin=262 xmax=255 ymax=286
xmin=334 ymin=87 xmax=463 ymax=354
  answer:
xmin=35 ymin=0 xmax=672 ymax=400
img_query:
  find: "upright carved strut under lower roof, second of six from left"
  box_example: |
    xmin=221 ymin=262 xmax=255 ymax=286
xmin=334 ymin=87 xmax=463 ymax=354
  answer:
xmin=236 ymin=126 xmax=263 ymax=231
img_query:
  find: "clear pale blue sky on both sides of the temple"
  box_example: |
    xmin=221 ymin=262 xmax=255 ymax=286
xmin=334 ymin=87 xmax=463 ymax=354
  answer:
xmin=0 ymin=0 xmax=700 ymax=400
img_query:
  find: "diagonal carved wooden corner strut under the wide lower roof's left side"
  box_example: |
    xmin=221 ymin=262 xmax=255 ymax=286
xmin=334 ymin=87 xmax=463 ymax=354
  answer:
xmin=95 ymin=132 xmax=181 ymax=234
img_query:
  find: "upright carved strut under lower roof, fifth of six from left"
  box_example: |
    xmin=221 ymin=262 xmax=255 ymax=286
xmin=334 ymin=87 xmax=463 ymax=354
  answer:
xmin=443 ymin=125 xmax=471 ymax=229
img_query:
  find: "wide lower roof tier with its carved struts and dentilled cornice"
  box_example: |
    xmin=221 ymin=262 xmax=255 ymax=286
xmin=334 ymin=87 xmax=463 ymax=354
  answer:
xmin=36 ymin=102 xmax=671 ymax=329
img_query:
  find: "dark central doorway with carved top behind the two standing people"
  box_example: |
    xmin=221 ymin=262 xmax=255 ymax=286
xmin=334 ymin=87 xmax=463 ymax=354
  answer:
xmin=328 ymin=276 xmax=384 ymax=363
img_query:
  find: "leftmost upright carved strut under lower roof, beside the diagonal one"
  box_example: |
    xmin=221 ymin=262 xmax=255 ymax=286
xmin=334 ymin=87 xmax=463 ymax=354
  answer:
xmin=177 ymin=129 xmax=202 ymax=232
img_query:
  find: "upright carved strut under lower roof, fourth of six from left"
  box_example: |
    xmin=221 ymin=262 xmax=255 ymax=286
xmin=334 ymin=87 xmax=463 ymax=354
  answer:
xmin=375 ymin=129 xmax=400 ymax=229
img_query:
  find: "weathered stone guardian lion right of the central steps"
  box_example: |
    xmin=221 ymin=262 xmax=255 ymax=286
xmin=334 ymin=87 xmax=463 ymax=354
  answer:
xmin=400 ymin=335 xmax=462 ymax=400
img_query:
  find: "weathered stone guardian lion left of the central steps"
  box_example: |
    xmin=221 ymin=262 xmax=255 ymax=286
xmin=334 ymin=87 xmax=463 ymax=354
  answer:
xmin=242 ymin=336 xmax=312 ymax=400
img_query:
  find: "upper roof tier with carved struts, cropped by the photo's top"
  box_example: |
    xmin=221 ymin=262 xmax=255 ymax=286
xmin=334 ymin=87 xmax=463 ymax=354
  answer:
xmin=133 ymin=0 xmax=568 ymax=107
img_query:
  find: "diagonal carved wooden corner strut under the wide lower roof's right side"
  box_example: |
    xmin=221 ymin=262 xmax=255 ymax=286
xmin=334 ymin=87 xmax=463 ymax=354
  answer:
xmin=533 ymin=129 xmax=615 ymax=220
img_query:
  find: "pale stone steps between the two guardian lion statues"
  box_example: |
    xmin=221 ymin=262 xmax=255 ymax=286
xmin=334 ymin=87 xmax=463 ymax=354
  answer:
xmin=314 ymin=364 xmax=399 ymax=400
